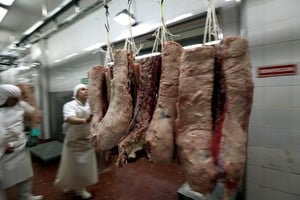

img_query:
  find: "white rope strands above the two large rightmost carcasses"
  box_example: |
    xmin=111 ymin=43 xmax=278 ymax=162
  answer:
xmin=203 ymin=0 xmax=223 ymax=44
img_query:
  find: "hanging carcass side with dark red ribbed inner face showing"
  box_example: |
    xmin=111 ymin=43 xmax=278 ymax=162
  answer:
xmin=117 ymin=55 xmax=161 ymax=166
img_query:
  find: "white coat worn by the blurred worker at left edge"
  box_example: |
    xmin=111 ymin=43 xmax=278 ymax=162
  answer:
xmin=0 ymin=101 xmax=34 ymax=188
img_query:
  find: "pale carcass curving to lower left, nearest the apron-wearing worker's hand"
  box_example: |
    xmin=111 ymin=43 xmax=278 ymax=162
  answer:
xmin=91 ymin=49 xmax=133 ymax=151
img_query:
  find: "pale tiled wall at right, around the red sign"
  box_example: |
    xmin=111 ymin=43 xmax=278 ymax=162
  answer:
xmin=244 ymin=0 xmax=300 ymax=200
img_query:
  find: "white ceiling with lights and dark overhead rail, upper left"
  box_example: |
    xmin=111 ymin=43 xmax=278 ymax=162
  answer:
xmin=0 ymin=0 xmax=109 ymax=68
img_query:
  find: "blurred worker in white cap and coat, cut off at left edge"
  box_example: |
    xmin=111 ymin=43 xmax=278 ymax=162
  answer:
xmin=0 ymin=84 xmax=43 ymax=200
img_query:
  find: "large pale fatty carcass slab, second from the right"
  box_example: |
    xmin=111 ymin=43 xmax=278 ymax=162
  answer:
xmin=176 ymin=46 xmax=217 ymax=194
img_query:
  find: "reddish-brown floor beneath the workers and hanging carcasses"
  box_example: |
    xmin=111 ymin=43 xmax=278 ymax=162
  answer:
xmin=8 ymin=152 xmax=185 ymax=200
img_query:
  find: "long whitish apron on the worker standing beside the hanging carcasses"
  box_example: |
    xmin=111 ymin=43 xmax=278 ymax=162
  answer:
xmin=55 ymin=101 xmax=98 ymax=190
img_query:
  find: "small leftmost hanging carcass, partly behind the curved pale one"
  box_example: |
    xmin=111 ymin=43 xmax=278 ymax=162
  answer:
xmin=88 ymin=66 xmax=108 ymax=132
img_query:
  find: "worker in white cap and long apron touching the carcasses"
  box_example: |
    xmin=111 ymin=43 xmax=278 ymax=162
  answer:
xmin=55 ymin=84 xmax=98 ymax=199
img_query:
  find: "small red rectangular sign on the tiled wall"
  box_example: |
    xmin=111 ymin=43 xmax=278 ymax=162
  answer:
xmin=257 ymin=64 xmax=297 ymax=78
